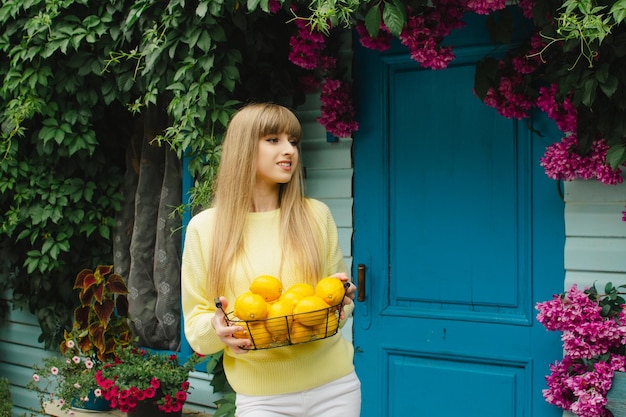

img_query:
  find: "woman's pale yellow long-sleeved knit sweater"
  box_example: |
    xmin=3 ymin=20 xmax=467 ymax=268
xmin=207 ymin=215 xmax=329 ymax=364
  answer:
xmin=181 ymin=199 xmax=354 ymax=395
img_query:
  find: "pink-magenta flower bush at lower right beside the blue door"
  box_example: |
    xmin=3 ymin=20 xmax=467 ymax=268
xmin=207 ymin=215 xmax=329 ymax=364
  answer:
xmin=536 ymin=285 xmax=626 ymax=417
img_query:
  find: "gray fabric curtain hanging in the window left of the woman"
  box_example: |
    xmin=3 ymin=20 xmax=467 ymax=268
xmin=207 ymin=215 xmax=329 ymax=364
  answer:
xmin=114 ymin=111 xmax=182 ymax=350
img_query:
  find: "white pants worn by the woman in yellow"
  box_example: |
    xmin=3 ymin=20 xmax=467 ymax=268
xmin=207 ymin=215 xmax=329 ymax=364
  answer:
xmin=235 ymin=372 xmax=361 ymax=417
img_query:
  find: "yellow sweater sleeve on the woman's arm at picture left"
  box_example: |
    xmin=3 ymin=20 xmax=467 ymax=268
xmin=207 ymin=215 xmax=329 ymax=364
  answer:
xmin=181 ymin=212 xmax=224 ymax=355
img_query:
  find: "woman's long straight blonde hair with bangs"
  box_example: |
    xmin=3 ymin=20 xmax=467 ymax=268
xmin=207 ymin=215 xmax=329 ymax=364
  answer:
xmin=207 ymin=103 xmax=323 ymax=297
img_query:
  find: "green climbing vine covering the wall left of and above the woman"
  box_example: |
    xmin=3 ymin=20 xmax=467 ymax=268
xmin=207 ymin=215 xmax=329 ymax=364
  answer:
xmin=0 ymin=0 xmax=310 ymax=348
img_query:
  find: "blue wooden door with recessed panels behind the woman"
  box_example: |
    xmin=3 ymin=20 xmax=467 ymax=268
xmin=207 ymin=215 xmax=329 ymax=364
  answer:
xmin=353 ymin=13 xmax=564 ymax=417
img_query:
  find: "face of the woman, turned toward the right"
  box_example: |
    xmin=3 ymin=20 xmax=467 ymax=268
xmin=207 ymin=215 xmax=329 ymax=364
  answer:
xmin=256 ymin=133 xmax=299 ymax=186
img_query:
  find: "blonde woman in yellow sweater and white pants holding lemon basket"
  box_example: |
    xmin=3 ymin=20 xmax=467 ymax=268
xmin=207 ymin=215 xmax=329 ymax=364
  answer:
xmin=182 ymin=103 xmax=361 ymax=417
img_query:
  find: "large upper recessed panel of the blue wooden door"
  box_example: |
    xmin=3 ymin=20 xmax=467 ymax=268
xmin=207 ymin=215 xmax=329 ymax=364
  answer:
xmin=385 ymin=51 xmax=529 ymax=314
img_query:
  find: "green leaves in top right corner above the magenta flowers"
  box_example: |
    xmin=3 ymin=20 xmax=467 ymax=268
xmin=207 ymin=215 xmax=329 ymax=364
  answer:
xmin=539 ymin=0 xmax=626 ymax=162
